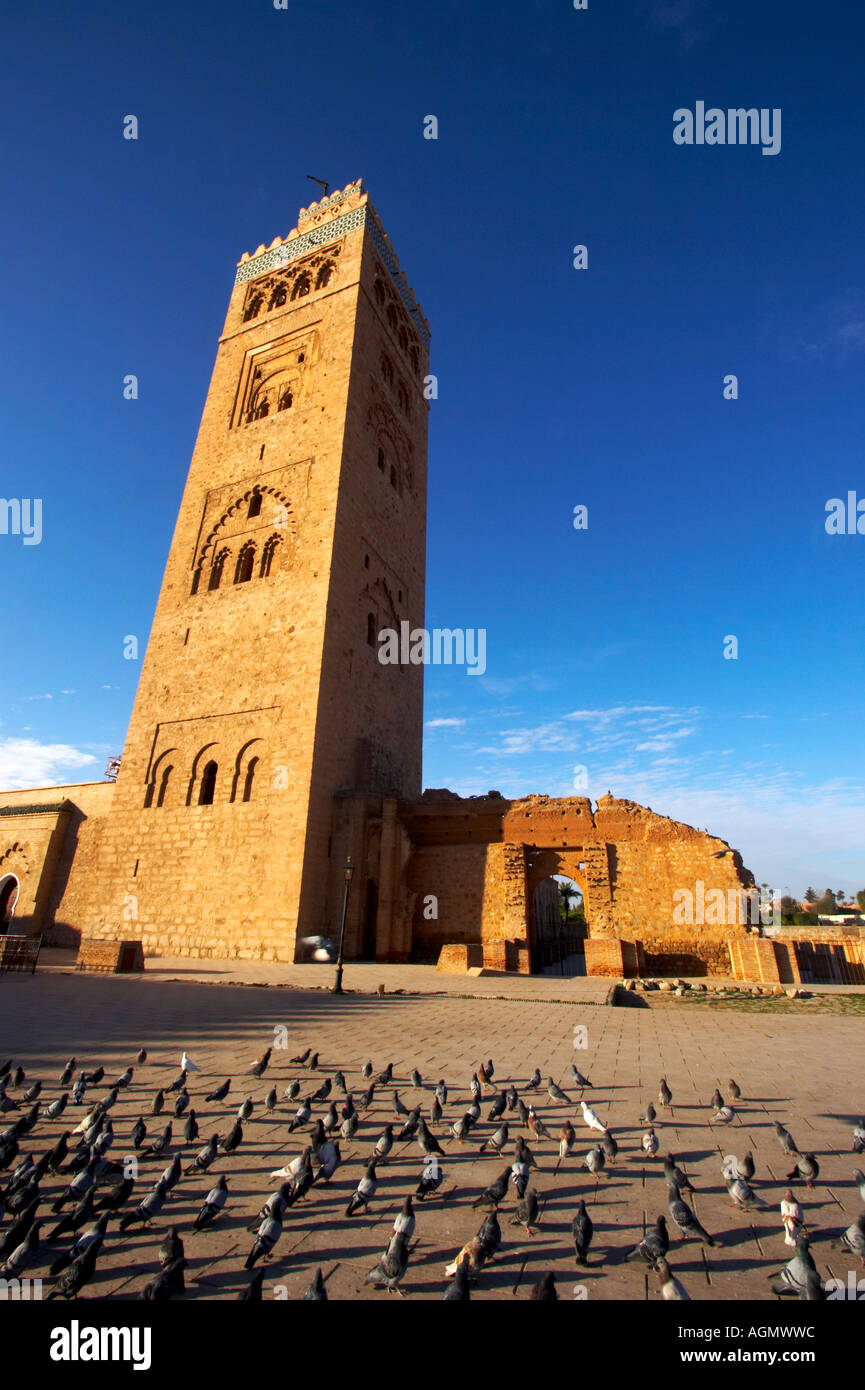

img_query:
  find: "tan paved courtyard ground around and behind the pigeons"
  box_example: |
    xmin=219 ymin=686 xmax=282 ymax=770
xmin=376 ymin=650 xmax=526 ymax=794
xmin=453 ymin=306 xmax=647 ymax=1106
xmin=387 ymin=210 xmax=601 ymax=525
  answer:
xmin=0 ymin=960 xmax=865 ymax=1302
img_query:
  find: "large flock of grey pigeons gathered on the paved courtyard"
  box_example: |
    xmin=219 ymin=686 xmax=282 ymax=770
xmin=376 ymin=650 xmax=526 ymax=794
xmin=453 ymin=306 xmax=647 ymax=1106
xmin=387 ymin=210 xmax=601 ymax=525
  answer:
xmin=0 ymin=1047 xmax=865 ymax=1301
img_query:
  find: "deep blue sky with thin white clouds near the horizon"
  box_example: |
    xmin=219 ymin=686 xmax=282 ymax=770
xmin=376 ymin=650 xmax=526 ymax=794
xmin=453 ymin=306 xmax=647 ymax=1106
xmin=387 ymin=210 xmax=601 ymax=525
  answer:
xmin=0 ymin=0 xmax=865 ymax=892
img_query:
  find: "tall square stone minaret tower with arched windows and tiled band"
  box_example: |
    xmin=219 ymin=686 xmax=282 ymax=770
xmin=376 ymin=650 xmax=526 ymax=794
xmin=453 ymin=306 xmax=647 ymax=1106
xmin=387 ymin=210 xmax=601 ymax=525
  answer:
xmin=63 ymin=181 xmax=430 ymax=960
